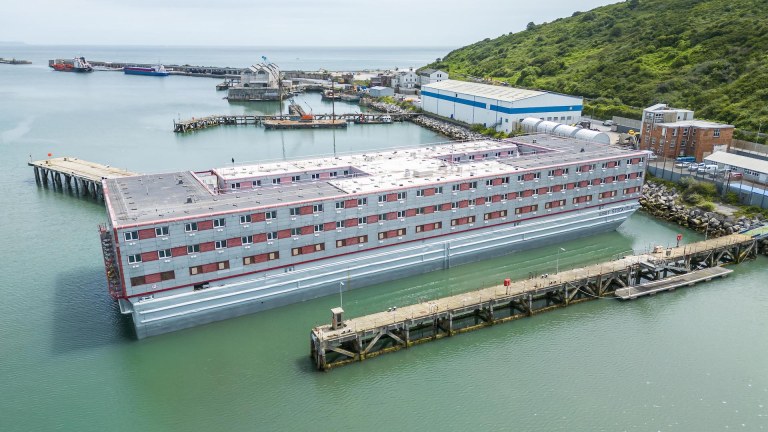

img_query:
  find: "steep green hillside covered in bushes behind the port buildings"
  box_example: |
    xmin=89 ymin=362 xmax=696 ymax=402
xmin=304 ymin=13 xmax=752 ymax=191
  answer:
xmin=430 ymin=0 xmax=768 ymax=138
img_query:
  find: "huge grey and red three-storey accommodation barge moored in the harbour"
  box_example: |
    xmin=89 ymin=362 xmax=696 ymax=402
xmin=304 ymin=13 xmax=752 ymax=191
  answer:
xmin=100 ymin=134 xmax=645 ymax=338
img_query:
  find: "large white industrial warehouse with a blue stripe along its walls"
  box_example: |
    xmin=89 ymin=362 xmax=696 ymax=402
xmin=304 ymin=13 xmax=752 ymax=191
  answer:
xmin=421 ymin=79 xmax=583 ymax=133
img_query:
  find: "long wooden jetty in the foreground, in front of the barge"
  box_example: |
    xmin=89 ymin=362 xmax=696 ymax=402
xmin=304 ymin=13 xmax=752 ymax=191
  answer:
xmin=310 ymin=234 xmax=757 ymax=370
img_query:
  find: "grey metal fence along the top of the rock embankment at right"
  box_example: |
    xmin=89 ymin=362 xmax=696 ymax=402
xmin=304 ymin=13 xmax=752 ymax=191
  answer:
xmin=648 ymin=159 xmax=768 ymax=208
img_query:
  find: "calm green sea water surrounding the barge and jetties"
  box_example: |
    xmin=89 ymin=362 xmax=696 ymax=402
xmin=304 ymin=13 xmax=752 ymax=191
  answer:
xmin=0 ymin=47 xmax=768 ymax=431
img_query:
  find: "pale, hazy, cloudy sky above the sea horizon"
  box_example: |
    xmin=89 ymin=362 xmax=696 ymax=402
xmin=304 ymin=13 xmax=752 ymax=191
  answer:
xmin=0 ymin=0 xmax=616 ymax=47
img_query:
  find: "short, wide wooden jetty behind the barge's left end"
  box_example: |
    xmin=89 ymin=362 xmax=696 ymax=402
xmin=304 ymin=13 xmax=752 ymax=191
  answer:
xmin=27 ymin=157 xmax=139 ymax=198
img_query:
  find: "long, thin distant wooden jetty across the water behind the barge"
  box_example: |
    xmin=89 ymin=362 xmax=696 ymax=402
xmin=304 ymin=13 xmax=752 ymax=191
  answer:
xmin=173 ymin=113 xmax=419 ymax=133
